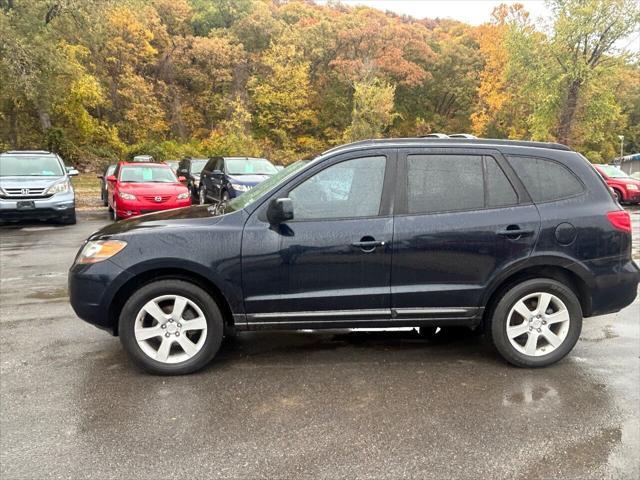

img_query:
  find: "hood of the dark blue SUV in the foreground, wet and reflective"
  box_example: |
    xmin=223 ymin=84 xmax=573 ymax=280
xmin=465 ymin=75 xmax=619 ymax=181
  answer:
xmin=90 ymin=205 xmax=228 ymax=240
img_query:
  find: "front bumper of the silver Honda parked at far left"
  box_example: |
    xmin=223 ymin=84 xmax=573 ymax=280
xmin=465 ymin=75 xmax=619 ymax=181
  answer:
xmin=0 ymin=192 xmax=76 ymax=220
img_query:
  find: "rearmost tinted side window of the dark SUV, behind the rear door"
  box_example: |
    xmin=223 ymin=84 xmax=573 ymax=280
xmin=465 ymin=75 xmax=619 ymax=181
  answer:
xmin=509 ymin=156 xmax=583 ymax=202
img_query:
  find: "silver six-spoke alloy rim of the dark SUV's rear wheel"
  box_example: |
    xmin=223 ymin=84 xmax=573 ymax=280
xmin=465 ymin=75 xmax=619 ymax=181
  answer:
xmin=506 ymin=292 xmax=571 ymax=357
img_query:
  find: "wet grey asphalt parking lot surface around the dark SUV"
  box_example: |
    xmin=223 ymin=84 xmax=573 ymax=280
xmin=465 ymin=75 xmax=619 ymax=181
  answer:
xmin=0 ymin=209 xmax=640 ymax=479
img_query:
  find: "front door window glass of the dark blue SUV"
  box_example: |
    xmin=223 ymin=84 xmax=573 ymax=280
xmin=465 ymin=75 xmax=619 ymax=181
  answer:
xmin=289 ymin=157 xmax=386 ymax=220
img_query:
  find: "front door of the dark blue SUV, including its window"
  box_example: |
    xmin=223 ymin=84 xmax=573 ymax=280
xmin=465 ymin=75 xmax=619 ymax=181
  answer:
xmin=242 ymin=150 xmax=395 ymax=328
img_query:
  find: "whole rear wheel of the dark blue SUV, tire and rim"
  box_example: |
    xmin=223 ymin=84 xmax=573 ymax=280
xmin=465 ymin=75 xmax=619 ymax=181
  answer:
xmin=488 ymin=278 xmax=582 ymax=367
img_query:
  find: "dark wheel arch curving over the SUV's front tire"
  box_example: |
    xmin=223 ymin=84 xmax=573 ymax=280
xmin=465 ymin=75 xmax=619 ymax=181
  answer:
xmin=108 ymin=267 xmax=234 ymax=336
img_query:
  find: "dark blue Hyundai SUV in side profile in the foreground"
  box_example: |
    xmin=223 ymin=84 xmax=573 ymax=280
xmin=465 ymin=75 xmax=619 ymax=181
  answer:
xmin=69 ymin=138 xmax=640 ymax=374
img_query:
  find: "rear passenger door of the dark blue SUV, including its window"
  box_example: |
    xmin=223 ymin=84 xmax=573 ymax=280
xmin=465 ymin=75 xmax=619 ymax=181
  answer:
xmin=391 ymin=148 xmax=540 ymax=319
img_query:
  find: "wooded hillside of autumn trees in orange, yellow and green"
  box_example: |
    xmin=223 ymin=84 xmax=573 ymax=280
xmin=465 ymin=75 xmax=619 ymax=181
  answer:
xmin=0 ymin=0 xmax=640 ymax=168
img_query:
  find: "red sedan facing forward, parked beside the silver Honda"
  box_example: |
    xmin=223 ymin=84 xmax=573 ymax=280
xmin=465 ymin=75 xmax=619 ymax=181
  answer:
xmin=107 ymin=162 xmax=191 ymax=220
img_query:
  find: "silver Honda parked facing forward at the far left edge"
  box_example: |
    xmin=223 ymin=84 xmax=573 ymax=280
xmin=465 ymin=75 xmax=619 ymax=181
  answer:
xmin=0 ymin=150 xmax=78 ymax=224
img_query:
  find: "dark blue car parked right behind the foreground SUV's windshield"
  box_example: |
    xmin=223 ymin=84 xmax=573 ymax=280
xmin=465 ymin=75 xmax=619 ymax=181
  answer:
xmin=198 ymin=157 xmax=278 ymax=204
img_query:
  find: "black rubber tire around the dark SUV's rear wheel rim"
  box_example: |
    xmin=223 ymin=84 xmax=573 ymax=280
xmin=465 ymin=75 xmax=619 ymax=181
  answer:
xmin=486 ymin=278 xmax=582 ymax=368
